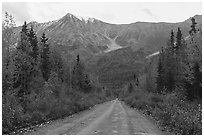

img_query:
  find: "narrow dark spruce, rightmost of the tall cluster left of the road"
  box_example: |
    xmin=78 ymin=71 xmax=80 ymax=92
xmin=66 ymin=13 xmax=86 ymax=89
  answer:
xmin=40 ymin=33 xmax=50 ymax=81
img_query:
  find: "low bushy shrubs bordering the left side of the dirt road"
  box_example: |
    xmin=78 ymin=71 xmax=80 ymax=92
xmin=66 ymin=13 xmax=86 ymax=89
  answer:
xmin=2 ymin=73 xmax=109 ymax=134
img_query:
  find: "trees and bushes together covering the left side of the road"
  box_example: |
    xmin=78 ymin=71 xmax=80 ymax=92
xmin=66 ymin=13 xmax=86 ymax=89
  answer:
xmin=2 ymin=13 xmax=112 ymax=134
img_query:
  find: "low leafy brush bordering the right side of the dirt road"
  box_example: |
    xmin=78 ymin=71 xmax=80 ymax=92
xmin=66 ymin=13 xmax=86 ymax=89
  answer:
xmin=122 ymin=86 xmax=202 ymax=135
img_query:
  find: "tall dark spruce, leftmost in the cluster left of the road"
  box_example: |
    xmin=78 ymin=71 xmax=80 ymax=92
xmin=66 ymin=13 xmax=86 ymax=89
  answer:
xmin=14 ymin=22 xmax=34 ymax=105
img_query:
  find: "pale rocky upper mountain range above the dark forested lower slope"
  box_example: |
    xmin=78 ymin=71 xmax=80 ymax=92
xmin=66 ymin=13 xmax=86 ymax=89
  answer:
xmin=13 ymin=13 xmax=202 ymax=55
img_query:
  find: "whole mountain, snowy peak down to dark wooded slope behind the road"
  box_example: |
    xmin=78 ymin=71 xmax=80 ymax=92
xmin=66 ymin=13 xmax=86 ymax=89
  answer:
xmin=9 ymin=14 xmax=202 ymax=87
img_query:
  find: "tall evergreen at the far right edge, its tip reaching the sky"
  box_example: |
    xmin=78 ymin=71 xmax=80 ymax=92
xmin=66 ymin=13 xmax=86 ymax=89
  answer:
xmin=185 ymin=18 xmax=202 ymax=101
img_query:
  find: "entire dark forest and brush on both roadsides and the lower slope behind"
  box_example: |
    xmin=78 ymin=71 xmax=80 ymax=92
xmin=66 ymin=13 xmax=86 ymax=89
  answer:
xmin=2 ymin=13 xmax=202 ymax=135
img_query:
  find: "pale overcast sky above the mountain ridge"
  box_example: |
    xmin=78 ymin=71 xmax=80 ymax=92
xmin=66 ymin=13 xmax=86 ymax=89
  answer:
xmin=2 ymin=2 xmax=202 ymax=25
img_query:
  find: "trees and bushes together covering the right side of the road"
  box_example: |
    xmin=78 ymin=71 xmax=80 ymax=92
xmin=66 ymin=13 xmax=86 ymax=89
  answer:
xmin=120 ymin=18 xmax=202 ymax=135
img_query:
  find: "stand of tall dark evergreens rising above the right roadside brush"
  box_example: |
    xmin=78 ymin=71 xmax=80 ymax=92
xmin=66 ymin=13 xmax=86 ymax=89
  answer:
xmin=156 ymin=18 xmax=202 ymax=101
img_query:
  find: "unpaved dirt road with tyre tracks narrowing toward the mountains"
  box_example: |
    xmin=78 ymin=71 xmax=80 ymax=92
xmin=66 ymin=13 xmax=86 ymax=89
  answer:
xmin=28 ymin=99 xmax=164 ymax=135
